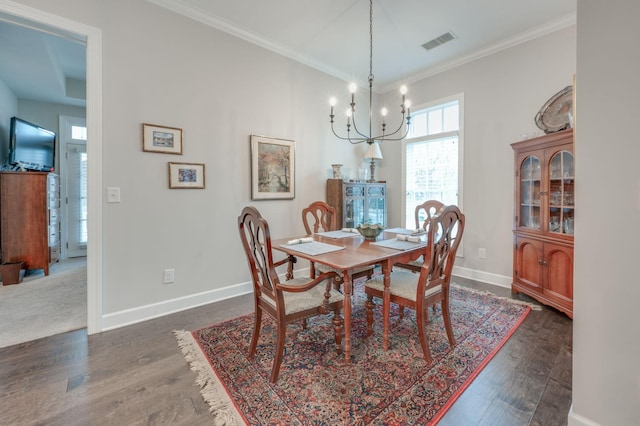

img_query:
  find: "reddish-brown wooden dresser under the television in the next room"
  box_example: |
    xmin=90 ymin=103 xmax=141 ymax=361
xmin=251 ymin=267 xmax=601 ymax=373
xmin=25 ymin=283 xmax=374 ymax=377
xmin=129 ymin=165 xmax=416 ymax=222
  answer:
xmin=0 ymin=172 xmax=60 ymax=275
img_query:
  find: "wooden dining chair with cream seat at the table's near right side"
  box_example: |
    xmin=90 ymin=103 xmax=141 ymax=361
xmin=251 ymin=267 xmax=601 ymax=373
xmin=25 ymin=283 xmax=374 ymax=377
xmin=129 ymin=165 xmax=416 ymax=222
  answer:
xmin=365 ymin=206 xmax=465 ymax=363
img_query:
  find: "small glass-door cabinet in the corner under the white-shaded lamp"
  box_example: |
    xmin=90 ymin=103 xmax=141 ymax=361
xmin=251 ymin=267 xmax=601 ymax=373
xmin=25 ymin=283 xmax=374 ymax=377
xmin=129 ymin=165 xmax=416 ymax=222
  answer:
xmin=327 ymin=179 xmax=387 ymax=229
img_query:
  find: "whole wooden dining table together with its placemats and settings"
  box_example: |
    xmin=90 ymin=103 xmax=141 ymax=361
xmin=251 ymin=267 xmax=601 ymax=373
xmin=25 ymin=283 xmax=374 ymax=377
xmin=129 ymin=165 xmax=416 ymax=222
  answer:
xmin=272 ymin=228 xmax=427 ymax=363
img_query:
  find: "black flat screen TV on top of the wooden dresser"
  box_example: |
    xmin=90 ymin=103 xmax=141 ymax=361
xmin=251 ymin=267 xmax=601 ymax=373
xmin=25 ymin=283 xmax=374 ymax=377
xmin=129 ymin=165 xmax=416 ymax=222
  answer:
xmin=9 ymin=117 xmax=56 ymax=172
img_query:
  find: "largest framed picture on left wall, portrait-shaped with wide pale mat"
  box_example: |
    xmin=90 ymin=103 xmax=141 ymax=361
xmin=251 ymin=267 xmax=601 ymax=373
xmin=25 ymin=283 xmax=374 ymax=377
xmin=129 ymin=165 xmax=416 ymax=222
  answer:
xmin=251 ymin=135 xmax=295 ymax=200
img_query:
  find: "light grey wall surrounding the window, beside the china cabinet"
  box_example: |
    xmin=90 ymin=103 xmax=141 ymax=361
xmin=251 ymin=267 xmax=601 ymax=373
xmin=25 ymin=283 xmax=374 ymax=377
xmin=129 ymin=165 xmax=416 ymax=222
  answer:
xmin=379 ymin=26 xmax=579 ymax=285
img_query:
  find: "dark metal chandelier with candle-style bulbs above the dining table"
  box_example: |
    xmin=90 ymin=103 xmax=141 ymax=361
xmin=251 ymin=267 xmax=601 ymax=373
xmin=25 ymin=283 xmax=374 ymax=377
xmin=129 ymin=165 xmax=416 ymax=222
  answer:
xmin=329 ymin=0 xmax=411 ymax=145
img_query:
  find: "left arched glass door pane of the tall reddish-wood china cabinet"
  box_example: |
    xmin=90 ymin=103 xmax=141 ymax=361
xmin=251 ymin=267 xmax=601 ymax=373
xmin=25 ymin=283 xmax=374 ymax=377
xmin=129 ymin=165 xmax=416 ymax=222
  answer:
xmin=518 ymin=156 xmax=541 ymax=229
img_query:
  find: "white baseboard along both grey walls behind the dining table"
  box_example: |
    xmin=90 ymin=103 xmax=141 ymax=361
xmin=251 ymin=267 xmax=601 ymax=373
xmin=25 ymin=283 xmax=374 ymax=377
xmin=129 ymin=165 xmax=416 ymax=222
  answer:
xmin=101 ymin=267 xmax=511 ymax=331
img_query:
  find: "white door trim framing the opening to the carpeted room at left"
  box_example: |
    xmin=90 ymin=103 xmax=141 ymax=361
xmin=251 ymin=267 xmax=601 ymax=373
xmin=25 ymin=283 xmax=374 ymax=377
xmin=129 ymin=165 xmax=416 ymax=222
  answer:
xmin=0 ymin=0 xmax=103 ymax=334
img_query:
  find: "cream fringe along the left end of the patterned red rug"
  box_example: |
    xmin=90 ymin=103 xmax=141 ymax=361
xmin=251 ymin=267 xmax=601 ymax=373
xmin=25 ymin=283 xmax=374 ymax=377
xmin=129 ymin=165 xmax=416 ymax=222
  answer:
xmin=173 ymin=330 xmax=245 ymax=426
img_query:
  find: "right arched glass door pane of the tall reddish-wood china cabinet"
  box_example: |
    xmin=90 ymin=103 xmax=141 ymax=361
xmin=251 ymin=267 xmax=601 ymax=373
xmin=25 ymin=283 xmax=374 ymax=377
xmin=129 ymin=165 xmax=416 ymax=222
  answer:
xmin=548 ymin=151 xmax=574 ymax=235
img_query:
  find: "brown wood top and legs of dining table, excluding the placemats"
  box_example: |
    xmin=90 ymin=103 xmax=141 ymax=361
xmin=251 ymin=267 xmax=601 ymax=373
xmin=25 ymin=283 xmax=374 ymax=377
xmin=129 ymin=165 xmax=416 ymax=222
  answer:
xmin=272 ymin=228 xmax=426 ymax=362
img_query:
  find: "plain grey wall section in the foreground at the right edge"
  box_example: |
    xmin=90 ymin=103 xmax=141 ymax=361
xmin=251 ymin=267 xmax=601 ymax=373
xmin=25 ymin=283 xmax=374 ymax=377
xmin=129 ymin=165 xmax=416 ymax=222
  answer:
xmin=569 ymin=0 xmax=640 ymax=426
